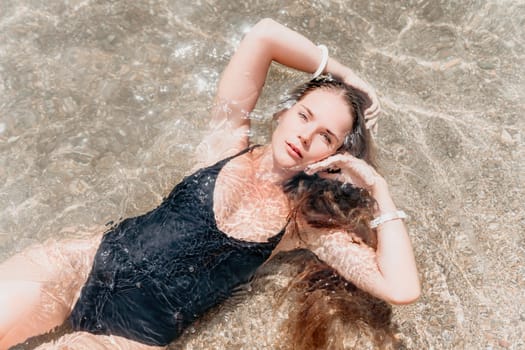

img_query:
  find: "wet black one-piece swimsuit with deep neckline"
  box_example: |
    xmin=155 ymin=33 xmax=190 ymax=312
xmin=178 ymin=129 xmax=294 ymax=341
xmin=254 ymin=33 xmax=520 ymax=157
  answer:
xmin=70 ymin=150 xmax=285 ymax=345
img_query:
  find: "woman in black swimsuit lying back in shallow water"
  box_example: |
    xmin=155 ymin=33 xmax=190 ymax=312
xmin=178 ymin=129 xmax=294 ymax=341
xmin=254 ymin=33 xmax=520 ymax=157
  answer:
xmin=0 ymin=19 xmax=420 ymax=349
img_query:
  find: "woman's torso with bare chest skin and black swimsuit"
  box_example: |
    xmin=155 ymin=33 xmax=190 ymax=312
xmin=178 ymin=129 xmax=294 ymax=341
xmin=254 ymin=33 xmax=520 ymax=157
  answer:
xmin=70 ymin=147 xmax=288 ymax=345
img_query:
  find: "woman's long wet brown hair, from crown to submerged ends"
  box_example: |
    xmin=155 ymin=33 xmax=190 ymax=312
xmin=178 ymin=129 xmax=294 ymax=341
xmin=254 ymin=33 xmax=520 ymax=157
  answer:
xmin=283 ymin=77 xmax=397 ymax=350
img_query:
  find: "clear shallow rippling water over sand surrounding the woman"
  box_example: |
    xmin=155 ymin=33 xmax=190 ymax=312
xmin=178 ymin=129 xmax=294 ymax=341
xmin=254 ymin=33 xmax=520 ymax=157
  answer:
xmin=0 ymin=0 xmax=525 ymax=349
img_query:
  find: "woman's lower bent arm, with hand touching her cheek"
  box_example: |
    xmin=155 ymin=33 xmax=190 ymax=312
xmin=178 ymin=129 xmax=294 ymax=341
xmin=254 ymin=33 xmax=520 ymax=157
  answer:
xmin=309 ymin=154 xmax=421 ymax=304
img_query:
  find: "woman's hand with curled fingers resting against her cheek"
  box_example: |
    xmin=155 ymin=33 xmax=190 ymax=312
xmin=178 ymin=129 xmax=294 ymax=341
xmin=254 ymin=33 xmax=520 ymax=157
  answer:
xmin=304 ymin=153 xmax=383 ymax=190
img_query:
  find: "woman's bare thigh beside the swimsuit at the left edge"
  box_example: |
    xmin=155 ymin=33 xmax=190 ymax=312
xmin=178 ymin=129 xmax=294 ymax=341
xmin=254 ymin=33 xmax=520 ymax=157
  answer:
xmin=0 ymin=228 xmax=101 ymax=350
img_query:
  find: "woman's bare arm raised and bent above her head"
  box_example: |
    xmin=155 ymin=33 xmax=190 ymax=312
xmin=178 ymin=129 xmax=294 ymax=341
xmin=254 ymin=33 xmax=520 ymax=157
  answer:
xmin=192 ymin=19 xmax=377 ymax=166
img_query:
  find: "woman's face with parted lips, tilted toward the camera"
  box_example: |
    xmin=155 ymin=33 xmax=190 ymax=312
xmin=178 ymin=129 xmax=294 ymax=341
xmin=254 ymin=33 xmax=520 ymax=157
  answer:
xmin=272 ymin=89 xmax=352 ymax=171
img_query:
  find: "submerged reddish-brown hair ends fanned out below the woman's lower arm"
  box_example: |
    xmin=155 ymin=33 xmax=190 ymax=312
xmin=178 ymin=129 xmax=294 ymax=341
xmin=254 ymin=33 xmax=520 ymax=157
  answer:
xmin=281 ymin=255 xmax=400 ymax=350
